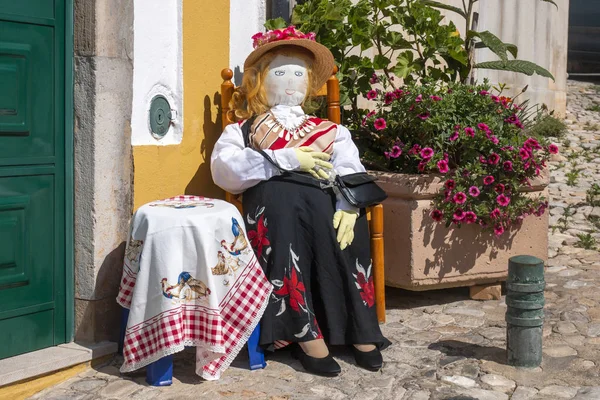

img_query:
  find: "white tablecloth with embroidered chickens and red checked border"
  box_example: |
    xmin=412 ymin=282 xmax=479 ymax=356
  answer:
xmin=117 ymin=196 xmax=272 ymax=380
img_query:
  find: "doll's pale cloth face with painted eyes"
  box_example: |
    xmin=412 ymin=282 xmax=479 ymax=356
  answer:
xmin=265 ymin=54 xmax=308 ymax=107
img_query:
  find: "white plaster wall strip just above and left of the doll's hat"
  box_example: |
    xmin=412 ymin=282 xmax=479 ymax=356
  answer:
xmin=229 ymin=0 xmax=267 ymax=85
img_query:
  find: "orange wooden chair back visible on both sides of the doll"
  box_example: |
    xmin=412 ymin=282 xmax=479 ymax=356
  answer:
xmin=221 ymin=67 xmax=342 ymax=212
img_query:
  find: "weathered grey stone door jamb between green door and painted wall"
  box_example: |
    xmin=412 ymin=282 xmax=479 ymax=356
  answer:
xmin=74 ymin=0 xmax=133 ymax=342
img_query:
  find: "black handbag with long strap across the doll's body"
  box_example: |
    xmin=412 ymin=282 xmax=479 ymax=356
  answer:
xmin=242 ymin=119 xmax=388 ymax=208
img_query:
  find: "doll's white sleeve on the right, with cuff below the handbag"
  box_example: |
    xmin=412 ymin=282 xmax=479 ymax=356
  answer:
xmin=331 ymin=125 xmax=366 ymax=213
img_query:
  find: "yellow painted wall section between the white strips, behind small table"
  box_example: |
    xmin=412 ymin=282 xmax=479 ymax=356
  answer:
xmin=133 ymin=0 xmax=229 ymax=209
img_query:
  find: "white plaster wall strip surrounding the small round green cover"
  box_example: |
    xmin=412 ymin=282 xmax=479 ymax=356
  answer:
xmin=131 ymin=0 xmax=183 ymax=146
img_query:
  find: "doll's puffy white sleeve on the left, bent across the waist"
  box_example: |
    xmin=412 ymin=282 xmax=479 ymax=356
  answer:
xmin=210 ymin=124 xmax=300 ymax=194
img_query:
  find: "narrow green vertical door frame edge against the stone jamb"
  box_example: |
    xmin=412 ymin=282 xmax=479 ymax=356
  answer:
xmin=64 ymin=0 xmax=75 ymax=343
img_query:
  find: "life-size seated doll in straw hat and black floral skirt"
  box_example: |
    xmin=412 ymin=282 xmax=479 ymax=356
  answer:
xmin=211 ymin=27 xmax=389 ymax=376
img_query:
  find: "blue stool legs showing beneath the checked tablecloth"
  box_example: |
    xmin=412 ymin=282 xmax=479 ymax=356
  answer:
xmin=119 ymin=308 xmax=267 ymax=386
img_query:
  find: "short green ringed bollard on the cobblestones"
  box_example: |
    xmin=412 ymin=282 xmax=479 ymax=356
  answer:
xmin=506 ymin=256 xmax=546 ymax=368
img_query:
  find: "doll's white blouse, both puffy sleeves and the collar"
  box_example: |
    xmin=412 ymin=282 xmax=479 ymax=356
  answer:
xmin=210 ymin=105 xmax=365 ymax=212
